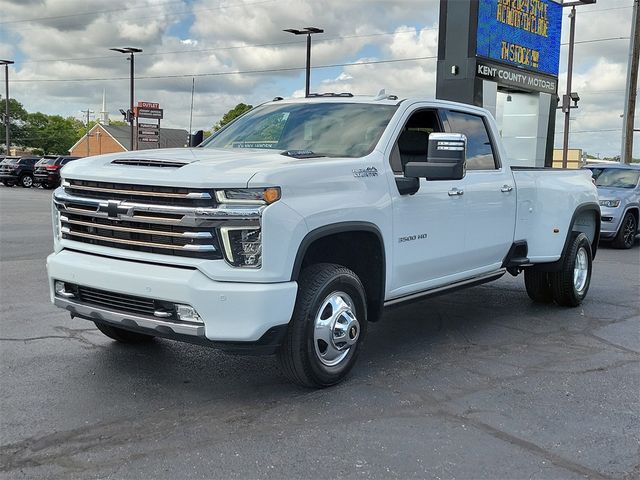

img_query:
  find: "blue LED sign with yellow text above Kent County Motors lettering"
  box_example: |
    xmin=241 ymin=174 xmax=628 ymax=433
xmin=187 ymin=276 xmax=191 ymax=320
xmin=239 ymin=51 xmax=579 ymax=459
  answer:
xmin=476 ymin=0 xmax=562 ymax=93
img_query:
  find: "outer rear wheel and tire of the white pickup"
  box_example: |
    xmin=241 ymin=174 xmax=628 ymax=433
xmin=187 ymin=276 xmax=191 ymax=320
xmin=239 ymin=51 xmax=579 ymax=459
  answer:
xmin=549 ymin=233 xmax=593 ymax=307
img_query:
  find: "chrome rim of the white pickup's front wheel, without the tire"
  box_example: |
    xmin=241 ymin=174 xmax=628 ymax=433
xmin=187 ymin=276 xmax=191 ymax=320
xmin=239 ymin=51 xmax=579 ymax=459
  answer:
xmin=313 ymin=292 xmax=360 ymax=367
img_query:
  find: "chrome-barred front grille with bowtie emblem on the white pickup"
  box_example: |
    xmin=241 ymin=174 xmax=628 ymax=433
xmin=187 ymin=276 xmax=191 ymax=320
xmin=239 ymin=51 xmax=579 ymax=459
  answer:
xmin=53 ymin=180 xmax=261 ymax=260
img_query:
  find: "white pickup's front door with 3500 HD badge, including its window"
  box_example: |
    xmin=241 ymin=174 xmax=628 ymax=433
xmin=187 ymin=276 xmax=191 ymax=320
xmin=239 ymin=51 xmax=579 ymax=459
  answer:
xmin=388 ymin=107 xmax=465 ymax=298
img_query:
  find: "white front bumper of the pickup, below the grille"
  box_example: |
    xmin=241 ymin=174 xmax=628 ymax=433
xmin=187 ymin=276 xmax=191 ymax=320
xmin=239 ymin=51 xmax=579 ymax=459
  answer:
xmin=47 ymin=250 xmax=297 ymax=346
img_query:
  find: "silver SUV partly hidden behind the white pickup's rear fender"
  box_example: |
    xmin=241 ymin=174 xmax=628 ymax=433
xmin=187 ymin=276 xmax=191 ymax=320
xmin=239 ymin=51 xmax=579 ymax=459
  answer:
xmin=585 ymin=164 xmax=640 ymax=248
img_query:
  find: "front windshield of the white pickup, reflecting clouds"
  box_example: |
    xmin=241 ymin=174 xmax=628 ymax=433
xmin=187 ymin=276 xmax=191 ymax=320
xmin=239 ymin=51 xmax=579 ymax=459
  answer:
xmin=203 ymin=103 xmax=397 ymax=158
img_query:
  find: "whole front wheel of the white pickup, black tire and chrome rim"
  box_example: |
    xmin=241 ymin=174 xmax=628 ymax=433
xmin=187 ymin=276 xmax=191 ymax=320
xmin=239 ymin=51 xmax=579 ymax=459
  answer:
xmin=278 ymin=263 xmax=367 ymax=388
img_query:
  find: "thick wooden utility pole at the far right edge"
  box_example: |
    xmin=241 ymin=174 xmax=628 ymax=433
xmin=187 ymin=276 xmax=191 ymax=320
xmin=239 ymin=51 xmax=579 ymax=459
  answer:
xmin=620 ymin=0 xmax=640 ymax=163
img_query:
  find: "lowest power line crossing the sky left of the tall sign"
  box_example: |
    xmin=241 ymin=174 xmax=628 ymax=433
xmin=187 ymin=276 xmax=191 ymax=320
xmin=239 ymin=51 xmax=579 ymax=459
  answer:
xmin=11 ymin=56 xmax=438 ymax=83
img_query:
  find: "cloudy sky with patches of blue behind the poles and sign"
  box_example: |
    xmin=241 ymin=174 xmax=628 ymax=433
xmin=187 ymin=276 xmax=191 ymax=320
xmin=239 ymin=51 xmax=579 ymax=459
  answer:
xmin=0 ymin=0 xmax=640 ymax=156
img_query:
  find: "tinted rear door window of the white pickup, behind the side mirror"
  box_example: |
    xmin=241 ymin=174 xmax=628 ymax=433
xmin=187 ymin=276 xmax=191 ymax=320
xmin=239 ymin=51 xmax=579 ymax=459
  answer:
xmin=447 ymin=111 xmax=498 ymax=170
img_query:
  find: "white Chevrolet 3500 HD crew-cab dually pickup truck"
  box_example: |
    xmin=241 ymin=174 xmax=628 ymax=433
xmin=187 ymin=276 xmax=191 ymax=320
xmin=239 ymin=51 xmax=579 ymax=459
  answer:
xmin=47 ymin=94 xmax=600 ymax=387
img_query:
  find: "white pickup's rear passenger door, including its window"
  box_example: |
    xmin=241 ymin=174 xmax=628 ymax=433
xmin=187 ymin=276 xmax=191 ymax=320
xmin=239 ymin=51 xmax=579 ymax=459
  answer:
xmin=443 ymin=110 xmax=516 ymax=273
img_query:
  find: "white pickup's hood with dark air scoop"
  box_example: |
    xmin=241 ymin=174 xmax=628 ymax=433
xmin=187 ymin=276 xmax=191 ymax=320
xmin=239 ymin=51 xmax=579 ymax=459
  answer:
xmin=62 ymin=148 xmax=297 ymax=188
